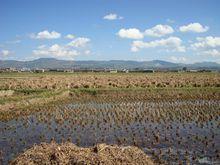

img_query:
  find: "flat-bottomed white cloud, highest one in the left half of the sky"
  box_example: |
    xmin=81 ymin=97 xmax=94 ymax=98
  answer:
xmin=30 ymin=30 xmax=61 ymax=39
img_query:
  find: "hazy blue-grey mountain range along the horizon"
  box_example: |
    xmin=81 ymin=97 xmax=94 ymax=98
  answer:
xmin=0 ymin=58 xmax=220 ymax=70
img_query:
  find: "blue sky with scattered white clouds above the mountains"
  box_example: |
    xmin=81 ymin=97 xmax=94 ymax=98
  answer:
xmin=0 ymin=0 xmax=220 ymax=63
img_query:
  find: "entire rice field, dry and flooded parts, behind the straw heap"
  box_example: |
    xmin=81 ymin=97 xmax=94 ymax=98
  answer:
xmin=0 ymin=73 xmax=220 ymax=164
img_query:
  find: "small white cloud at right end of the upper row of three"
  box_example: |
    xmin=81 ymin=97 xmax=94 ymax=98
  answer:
xmin=179 ymin=23 xmax=209 ymax=33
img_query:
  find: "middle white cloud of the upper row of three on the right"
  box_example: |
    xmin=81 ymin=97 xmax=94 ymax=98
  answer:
xmin=144 ymin=24 xmax=174 ymax=37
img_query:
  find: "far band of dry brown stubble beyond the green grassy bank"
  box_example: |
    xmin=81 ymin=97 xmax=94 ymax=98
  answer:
xmin=0 ymin=73 xmax=220 ymax=90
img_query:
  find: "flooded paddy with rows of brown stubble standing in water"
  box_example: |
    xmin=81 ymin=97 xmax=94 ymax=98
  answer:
xmin=0 ymin=91 xmax=220 ymax=164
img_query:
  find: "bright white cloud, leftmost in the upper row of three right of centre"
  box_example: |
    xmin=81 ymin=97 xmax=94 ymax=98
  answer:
xmin=118 ymin=28 xmax=144 ymax=39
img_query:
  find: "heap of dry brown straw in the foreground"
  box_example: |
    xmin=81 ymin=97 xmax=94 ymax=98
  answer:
xmin=10 ymin=142 xmax=154 ymax=165
